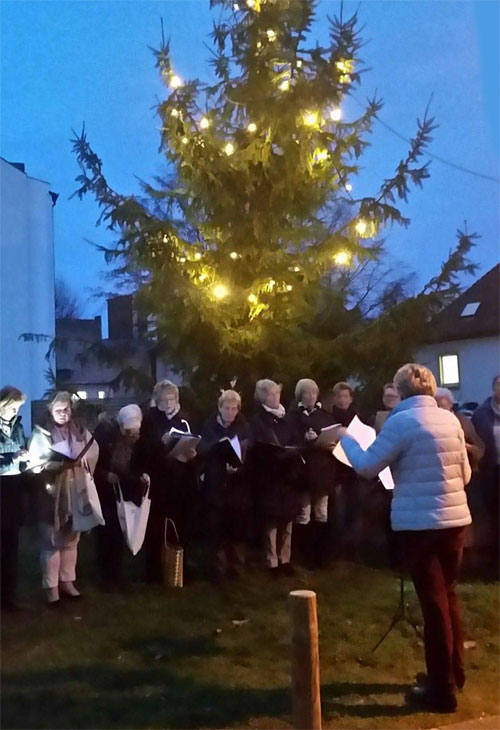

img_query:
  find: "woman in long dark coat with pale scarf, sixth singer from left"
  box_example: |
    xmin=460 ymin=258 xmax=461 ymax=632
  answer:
xmin=251 ymin=379 xmax=304 ymax=575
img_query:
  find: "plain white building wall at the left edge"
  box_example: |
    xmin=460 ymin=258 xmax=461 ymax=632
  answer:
xmin=0 ymin=159 xmax=55 ymax=431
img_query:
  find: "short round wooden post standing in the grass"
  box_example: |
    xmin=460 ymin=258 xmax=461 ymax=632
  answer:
xmin=289 ymin=591 xmax=321 ymax=730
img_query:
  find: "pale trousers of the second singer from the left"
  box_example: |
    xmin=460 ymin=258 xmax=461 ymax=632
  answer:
xmin=40 ymin=523 xmax=80 ymax=588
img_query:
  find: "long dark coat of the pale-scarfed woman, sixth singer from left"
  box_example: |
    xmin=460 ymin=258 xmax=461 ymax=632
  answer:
xmin=249 ymin=405 xmax=304 ymax=521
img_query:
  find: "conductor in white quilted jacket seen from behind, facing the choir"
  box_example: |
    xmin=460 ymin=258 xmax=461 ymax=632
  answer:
xmin=341 ymin=363 xmax=471 ymax=712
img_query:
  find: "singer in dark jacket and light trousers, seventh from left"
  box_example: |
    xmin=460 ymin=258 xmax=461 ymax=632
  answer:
xmin=289 ymin=378 xmax=338 ymax=567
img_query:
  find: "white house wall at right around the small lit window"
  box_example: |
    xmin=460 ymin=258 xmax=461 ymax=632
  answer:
xmin=416 ymin=337 xmax=500 ymax=403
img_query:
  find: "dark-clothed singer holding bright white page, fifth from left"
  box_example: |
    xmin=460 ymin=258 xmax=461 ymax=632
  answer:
xmin=198 ymin=390 xmax=252 ymax=581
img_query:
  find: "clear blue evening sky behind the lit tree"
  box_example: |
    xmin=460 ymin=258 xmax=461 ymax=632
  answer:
xmin=0 ymin=0 xmax=500 ymax=324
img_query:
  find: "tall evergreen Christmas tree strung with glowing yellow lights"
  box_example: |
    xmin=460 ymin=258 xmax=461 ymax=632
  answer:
xmin=73 ymin=0 xmax=470 ymax=398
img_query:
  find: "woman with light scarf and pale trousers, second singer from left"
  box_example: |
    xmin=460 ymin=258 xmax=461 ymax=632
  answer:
xmin=36 ymin=392 xmax=99 ymax=606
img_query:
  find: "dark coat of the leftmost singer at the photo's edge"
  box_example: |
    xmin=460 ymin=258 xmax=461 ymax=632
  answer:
xmin=0 ymin=416 xmax=27 ymax=528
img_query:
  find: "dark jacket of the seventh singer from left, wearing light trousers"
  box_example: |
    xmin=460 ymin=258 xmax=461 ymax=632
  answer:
xmin=289 ymin=405 xmax=338 ymax=496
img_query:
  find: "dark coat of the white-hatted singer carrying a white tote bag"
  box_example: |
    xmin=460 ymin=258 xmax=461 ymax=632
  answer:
xmin=94 ymin=421 xmax=144 ymax=505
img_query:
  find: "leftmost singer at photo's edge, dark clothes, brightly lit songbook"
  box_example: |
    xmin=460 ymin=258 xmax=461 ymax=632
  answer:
xmin=0 ymin=385 xmax=28 ymax=611
